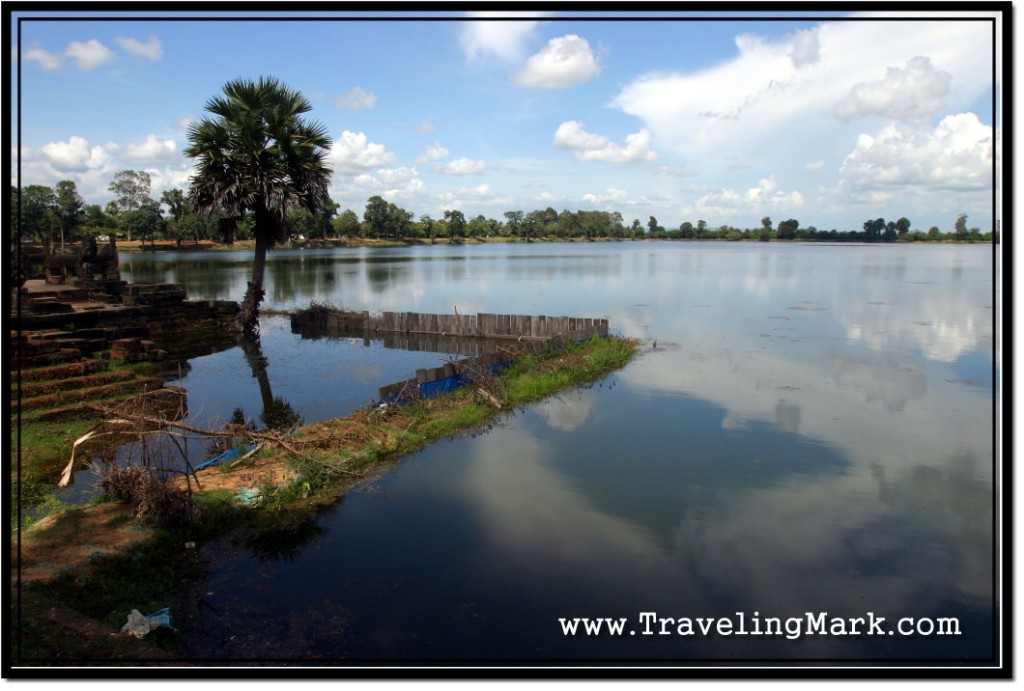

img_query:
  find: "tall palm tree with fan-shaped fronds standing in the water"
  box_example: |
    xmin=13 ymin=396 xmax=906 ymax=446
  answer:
xmin=184 ymin=77 xmax=331 ymax=333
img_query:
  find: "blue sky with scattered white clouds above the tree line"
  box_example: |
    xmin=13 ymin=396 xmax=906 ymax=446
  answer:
xmin=9 ymin=10 xmax=999 ymax=230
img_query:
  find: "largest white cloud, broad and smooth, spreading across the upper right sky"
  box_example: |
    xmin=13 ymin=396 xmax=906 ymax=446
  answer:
xmin=612 ymin=21 xmax=993 ymax=160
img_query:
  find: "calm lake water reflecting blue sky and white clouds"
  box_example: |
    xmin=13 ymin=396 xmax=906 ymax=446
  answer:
xmin=121 ymin=243 xmax=999 ymax=662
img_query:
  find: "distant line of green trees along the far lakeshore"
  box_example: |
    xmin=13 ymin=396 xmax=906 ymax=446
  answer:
xmin=10 ymin=170 xmax=997 ymax=248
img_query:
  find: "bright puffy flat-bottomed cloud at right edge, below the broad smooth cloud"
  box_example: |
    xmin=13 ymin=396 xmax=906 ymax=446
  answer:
xmin=840 ymin=113 xmax=993 ymax=191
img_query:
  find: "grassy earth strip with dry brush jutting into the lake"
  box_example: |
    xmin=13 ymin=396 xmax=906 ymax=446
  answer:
xmin=14 ymin=338 xmax=638 ymax=663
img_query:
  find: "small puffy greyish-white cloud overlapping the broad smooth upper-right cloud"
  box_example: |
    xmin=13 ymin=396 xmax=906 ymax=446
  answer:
xmin=835 ymin=55 xmax=952 ymax=122
